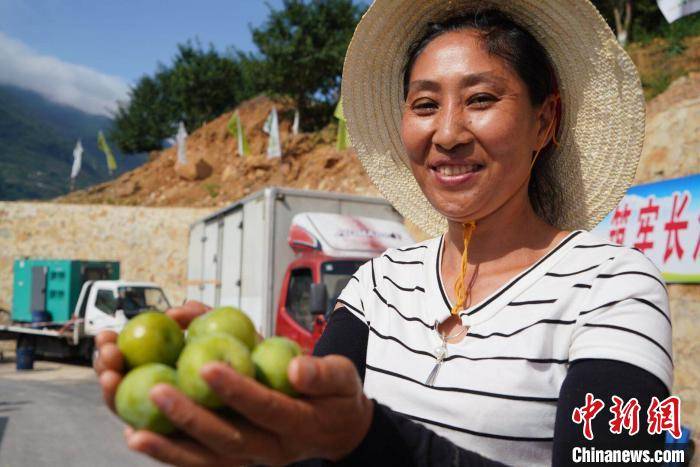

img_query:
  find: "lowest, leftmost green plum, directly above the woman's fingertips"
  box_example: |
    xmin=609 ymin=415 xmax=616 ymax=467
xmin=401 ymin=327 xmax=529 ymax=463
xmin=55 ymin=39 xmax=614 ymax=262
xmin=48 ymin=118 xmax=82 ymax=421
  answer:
xmin=114 ymin=363 xmax=177 ymax=435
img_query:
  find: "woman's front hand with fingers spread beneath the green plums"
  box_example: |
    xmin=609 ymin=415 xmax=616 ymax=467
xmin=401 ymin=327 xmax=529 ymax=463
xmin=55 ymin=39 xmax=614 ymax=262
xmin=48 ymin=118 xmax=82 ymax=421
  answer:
xmin=125 ymin=355 xmax=374 ymax=466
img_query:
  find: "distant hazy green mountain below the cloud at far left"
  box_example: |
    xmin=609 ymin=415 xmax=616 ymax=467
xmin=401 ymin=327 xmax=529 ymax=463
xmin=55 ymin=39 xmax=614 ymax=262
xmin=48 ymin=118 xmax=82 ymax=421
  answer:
xmin=0 ymin=85 xmax=146 ymax=200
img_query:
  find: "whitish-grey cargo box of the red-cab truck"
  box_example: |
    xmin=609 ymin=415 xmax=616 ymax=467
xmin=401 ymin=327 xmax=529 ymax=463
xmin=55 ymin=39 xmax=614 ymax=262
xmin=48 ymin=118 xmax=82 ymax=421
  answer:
xmin=187 ymin=188 xmax=403 ymax=336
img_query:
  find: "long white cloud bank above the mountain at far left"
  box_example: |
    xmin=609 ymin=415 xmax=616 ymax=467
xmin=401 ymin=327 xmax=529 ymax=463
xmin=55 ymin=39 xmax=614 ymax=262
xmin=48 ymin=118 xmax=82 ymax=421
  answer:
xmin=0 ymin=32 xmax=129 ymax=116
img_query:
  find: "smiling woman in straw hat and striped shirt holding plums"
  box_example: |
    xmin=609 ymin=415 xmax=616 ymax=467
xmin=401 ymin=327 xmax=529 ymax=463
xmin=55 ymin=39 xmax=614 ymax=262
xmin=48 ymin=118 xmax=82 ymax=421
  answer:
xmin=97 ymin=0 xmax=672 ymax=465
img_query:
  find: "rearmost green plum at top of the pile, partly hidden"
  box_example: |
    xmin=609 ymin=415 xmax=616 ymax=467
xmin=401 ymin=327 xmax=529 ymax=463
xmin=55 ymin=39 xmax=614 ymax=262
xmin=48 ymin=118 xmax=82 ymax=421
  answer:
xmin=187 ymin=306 xmax=257 ymax=350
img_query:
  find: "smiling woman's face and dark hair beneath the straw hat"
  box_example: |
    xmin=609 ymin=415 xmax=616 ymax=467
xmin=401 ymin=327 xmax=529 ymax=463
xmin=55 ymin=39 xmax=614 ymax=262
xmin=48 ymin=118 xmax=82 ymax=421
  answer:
xmin=401 ymin=10 xmax=559 ymax=228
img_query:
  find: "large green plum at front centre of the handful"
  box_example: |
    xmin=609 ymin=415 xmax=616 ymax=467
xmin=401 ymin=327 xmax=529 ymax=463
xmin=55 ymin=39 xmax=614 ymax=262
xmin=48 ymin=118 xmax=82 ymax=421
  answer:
xmin=177 ymin=333 xmax=255 ymax=409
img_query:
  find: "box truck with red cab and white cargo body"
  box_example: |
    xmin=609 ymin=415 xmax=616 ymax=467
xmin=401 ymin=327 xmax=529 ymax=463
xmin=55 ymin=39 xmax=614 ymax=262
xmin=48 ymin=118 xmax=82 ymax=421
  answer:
xmin=187 ymin=188 xmax=413 ymax=351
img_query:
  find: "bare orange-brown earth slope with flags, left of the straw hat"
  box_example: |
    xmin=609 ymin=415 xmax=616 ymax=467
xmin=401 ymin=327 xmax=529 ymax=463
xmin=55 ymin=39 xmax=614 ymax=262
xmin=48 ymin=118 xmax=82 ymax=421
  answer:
xmin=56 ymin=97 xmax=377 ymax=206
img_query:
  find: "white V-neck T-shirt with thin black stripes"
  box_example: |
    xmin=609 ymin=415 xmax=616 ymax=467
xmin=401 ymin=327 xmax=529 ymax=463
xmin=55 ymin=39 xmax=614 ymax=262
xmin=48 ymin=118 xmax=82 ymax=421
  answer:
xmin=338 ymin=231 xmax=673 ymax=465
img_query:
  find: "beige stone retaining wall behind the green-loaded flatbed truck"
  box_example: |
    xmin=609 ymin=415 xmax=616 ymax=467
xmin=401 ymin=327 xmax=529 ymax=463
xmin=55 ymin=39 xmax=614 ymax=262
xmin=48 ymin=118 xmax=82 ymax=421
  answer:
xmin=0 ymin=202 xmax=211 ymax=309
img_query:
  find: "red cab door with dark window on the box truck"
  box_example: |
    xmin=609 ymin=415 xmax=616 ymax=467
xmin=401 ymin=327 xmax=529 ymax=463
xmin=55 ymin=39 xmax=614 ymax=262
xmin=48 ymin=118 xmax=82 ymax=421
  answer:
xmin=277 ymin=267 xmax=314 ymax=352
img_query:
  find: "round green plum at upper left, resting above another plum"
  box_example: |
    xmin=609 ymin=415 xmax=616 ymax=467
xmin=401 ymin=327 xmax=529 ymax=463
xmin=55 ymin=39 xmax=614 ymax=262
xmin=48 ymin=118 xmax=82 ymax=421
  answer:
xmin=117 ymin=311 xmax=185 ymax=368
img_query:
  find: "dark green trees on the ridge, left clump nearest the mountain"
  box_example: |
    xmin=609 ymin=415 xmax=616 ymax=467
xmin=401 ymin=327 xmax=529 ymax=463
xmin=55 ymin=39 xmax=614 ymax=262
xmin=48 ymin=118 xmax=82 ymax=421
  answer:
xmin=111 ymin=41 xmax=260 ymax=153
